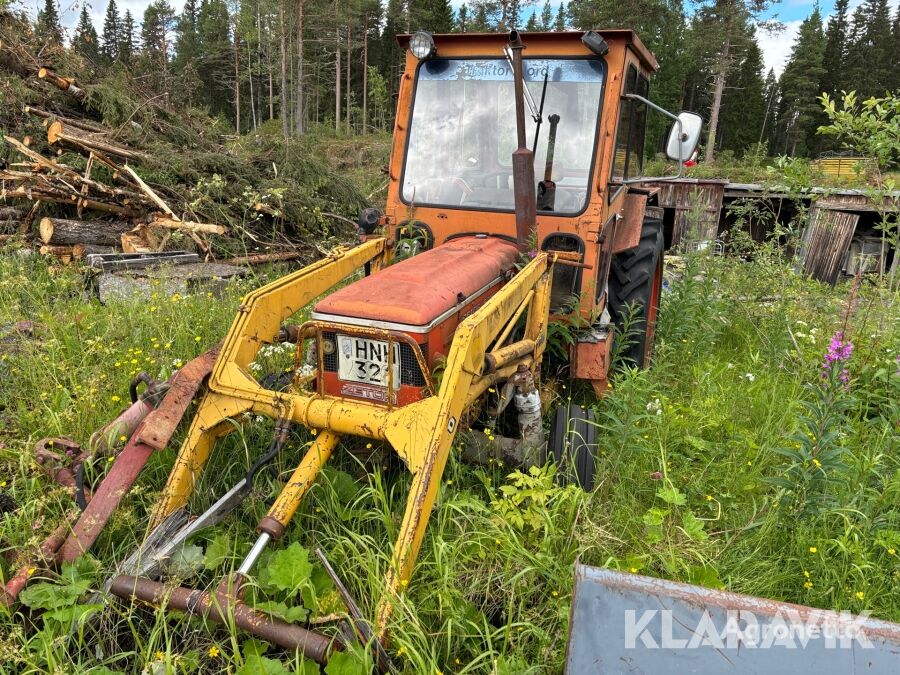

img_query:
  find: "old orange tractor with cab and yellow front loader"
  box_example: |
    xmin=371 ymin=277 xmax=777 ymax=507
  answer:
xmin=95 ymin=30 xmax=700 ymax=667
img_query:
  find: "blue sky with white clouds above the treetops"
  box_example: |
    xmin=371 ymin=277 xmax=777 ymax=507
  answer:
xmin=21 ymin=0 xmax=900 ymax=75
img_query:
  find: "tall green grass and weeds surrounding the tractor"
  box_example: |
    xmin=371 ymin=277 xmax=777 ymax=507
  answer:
xmin=0 ymin=240 xmax=900 ymax=675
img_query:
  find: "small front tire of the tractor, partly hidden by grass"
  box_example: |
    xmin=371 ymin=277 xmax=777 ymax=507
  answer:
xmin=549 ymin=403 xmax=597 ymax=492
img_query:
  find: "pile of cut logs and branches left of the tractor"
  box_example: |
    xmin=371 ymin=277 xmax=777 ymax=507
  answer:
xmin=0 ymin=26 xmax=310 ymax=264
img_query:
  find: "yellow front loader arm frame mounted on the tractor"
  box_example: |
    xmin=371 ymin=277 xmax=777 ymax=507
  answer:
xmin=135 ymin=238 xmax=555 ymax=648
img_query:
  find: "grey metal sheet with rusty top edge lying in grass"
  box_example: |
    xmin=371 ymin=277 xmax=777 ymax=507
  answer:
xmin=566 ymin=564 xmax=900 ymax=675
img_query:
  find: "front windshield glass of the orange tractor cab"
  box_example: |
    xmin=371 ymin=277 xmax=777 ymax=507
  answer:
xmin=402 ymin=59 xmax=604 ymax=214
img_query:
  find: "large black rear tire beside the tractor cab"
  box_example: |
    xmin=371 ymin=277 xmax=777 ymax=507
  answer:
xmin=608 ymin=218 xmax=664 ymax=368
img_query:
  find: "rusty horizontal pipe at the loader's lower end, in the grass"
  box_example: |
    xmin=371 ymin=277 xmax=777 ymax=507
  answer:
xmin=110 ymin=575 xmax=343 ymax=664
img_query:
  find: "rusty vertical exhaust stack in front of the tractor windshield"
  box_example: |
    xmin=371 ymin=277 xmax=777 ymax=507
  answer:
xmin=509 ymin=30 xmax=537 ymax=251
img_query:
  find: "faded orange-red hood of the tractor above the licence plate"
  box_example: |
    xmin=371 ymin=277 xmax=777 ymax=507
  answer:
xmin=313 ymin=236 xmax=518 ymax=332
